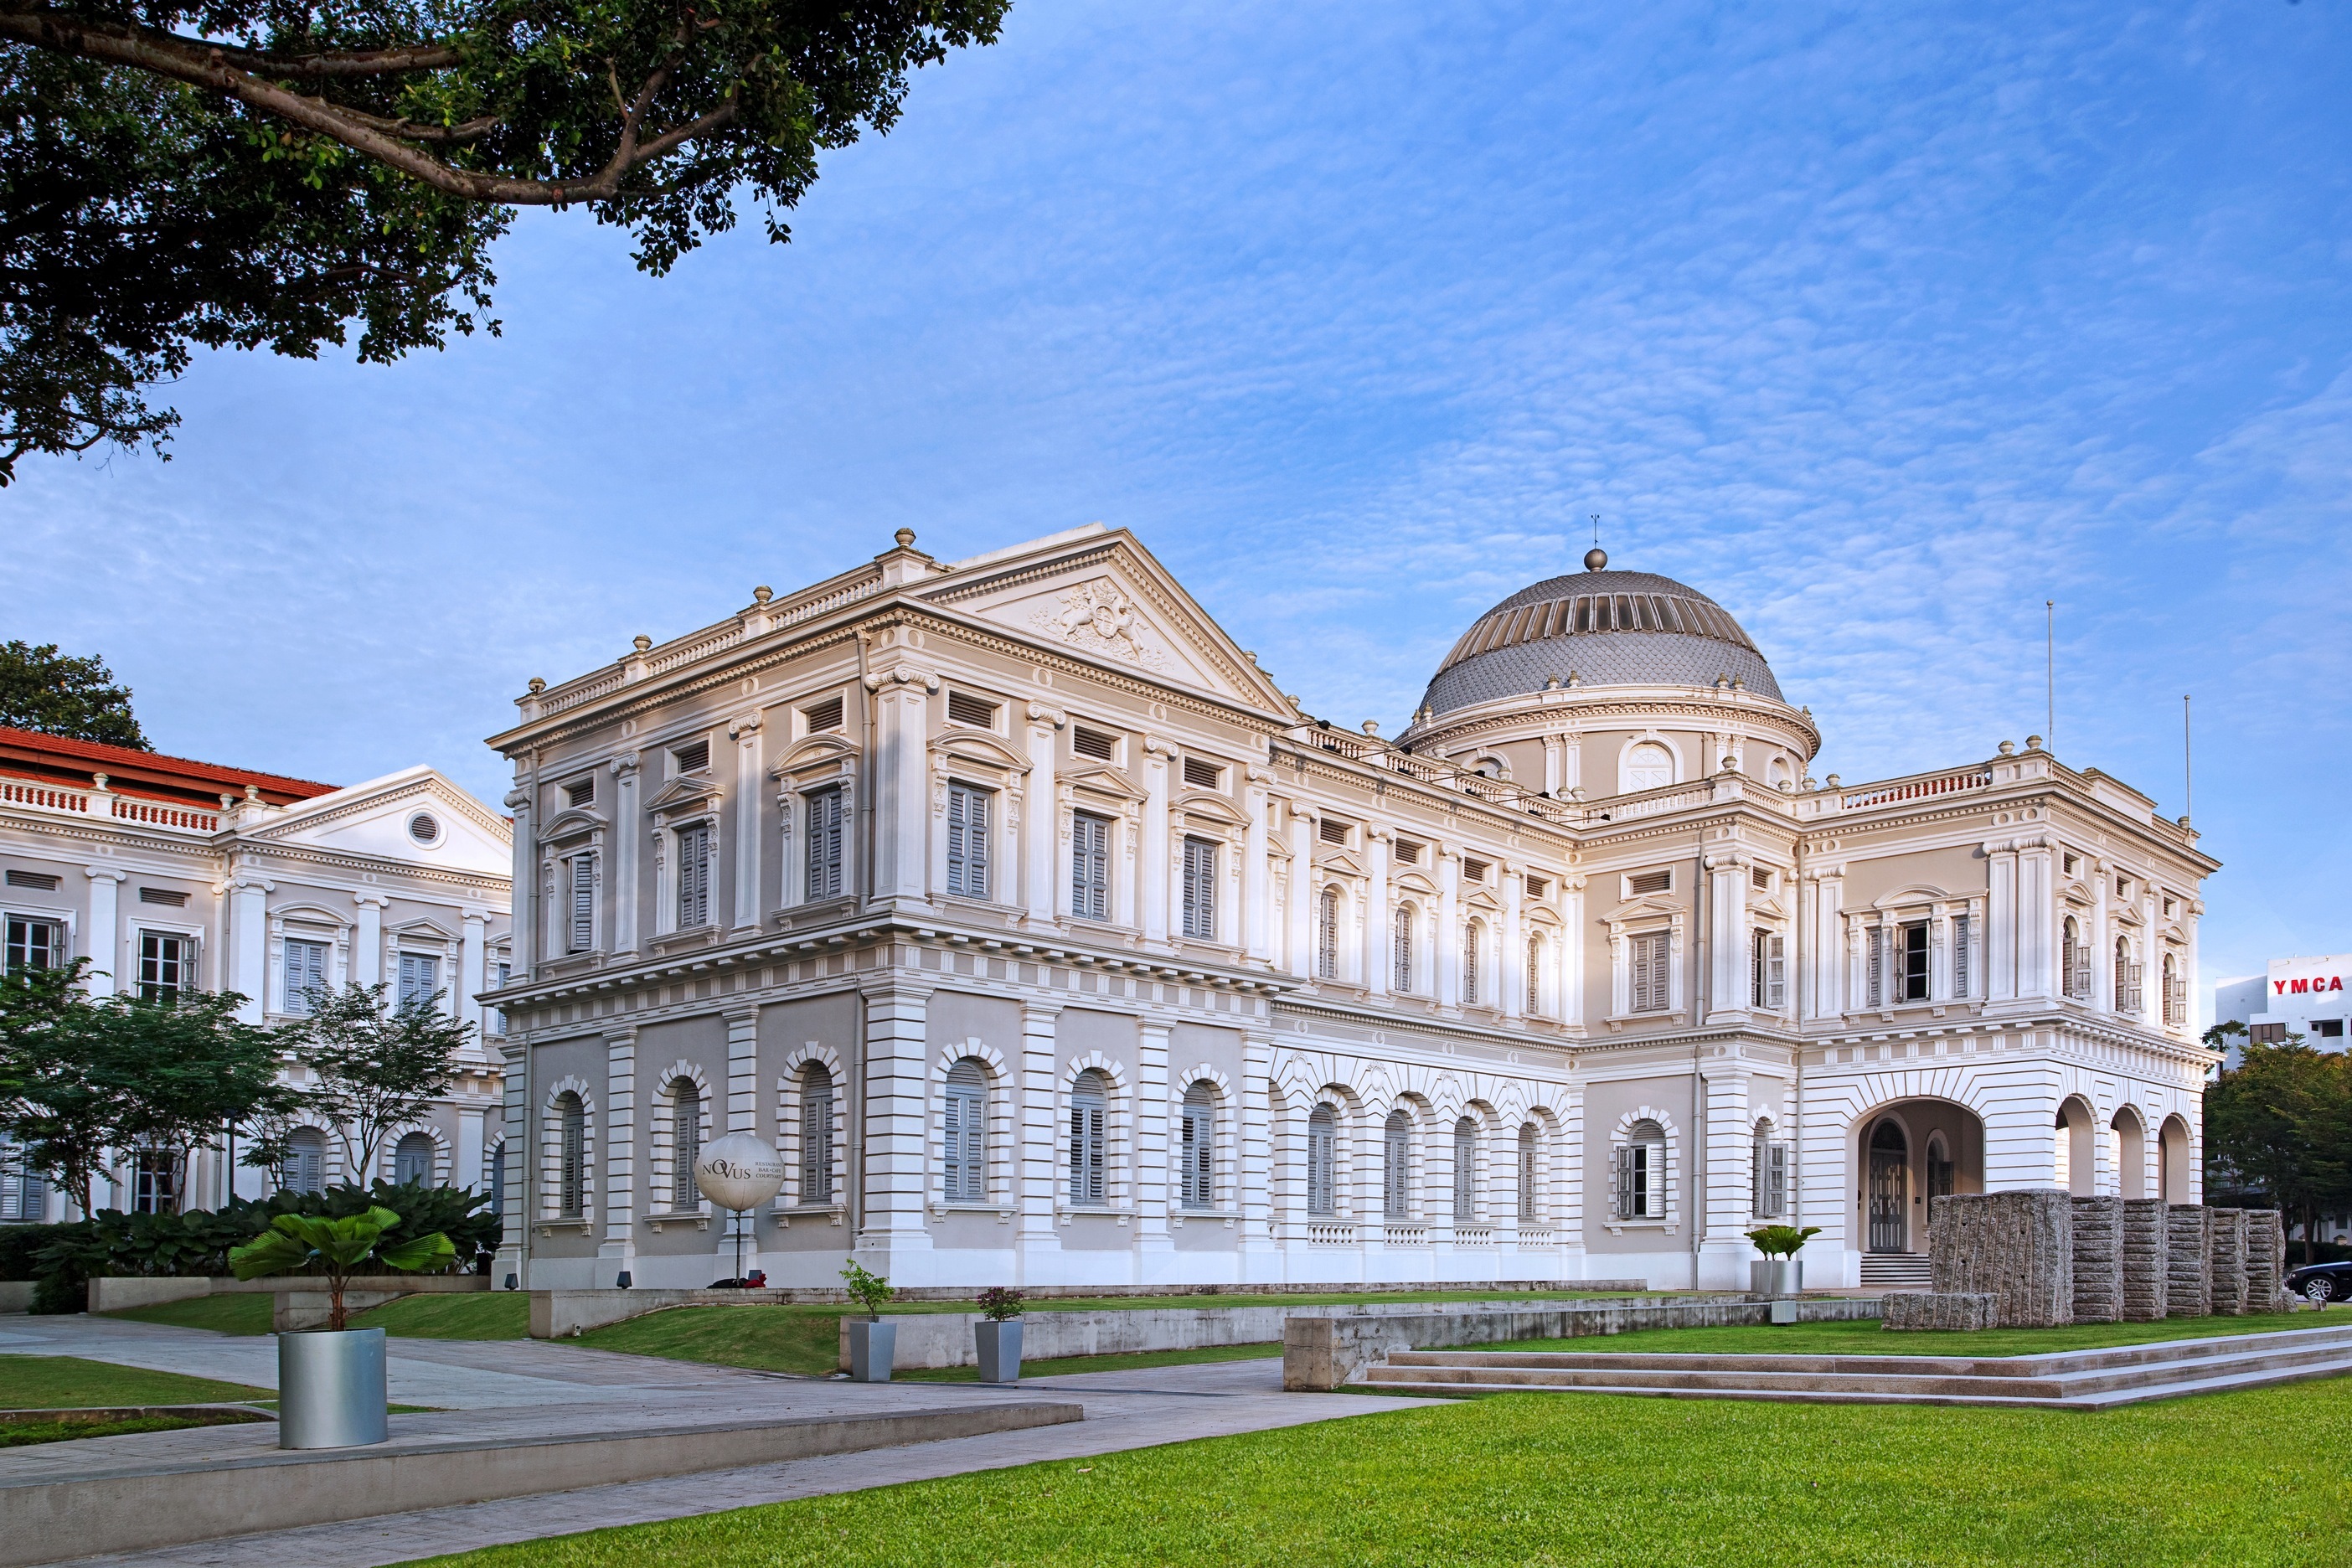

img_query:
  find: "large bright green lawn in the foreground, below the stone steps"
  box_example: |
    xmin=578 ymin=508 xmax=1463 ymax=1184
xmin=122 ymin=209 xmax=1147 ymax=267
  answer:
xmin=414 ymin=1382 xmax=2352 ymax=1568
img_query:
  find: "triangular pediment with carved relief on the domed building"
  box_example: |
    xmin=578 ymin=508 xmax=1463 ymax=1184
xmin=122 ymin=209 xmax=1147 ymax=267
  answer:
xmin=922 ymin=529 xmax=1298 ymax=720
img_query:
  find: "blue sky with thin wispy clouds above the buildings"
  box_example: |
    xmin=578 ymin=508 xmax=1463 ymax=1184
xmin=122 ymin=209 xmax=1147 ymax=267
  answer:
xmin=0 ymin=0 xmax=2352 ymax=1006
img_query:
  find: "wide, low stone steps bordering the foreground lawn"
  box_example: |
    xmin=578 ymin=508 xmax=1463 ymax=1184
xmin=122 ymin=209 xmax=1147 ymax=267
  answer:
xmin=1359 ymin=1323 xmax=2352 ymax=1411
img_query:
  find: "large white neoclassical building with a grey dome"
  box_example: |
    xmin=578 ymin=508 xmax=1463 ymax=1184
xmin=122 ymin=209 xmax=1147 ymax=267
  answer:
xmin=492 ymin=527 xmax=2215 ymax=1288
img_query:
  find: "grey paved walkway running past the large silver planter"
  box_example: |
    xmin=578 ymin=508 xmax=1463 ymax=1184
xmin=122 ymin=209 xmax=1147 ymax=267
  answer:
xmin=18 ymin=1317 xmax=1432 ymax=1568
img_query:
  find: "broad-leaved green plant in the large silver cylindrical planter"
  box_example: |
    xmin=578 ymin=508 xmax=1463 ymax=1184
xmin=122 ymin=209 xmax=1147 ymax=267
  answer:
xmin=228 ymin=1209 xmax=456 ymax=1448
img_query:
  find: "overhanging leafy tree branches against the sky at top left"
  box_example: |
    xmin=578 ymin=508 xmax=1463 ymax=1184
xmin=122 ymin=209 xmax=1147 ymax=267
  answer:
xmin=0 ymin=0 xmax=1009 ymax=484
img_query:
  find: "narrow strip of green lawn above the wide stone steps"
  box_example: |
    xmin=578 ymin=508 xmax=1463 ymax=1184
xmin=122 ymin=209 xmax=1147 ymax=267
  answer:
xmin=1463 ymin=1312 xmax=2347 ymax=1356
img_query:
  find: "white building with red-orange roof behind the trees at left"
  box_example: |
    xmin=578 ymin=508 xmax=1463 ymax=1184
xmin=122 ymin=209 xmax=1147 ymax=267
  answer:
xmin=0 ymin=729 xmax=513 ymax=1220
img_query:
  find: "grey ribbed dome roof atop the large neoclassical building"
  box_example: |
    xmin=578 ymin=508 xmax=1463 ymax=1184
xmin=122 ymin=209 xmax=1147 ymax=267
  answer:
xmin=1421 ymin=571 xmax=1782 ymax=714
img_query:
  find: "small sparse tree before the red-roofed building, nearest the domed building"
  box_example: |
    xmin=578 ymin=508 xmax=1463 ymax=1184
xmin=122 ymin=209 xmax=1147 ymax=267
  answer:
xmin=277 ymin=985 xmax=472 ymax=1180
